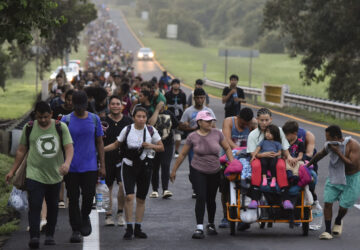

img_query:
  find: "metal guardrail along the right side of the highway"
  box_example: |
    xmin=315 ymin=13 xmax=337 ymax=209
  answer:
xmin=205 ymin=80 xmax=360 ymax=122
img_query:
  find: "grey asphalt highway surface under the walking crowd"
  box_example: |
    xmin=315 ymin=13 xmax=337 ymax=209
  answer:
xmin=4 ymin=5 xmax=360 ymax=250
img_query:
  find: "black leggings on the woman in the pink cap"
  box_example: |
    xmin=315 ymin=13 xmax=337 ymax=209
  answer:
xmin=190 ymin=166 xmax=220 ymax=224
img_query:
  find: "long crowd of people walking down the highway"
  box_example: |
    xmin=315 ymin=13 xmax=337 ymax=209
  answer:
xmin=6 ymin=3 xmax=360 ymax=248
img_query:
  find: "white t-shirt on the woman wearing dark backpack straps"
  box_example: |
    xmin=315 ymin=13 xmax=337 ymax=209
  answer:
xmin=117 ymin=124 xmax=161 ymax=166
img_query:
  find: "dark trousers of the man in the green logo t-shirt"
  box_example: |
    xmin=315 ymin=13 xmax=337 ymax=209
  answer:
xmin=25 ymin=179 xmax=61 ymax=238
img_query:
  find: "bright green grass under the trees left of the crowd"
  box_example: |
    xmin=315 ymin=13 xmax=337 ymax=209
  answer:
xmin=0 ymin=45 xmax=87 ymax=119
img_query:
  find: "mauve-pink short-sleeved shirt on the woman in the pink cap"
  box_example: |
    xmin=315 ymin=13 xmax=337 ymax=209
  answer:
xmin=186 ymin=128 xmax=224 ymax=174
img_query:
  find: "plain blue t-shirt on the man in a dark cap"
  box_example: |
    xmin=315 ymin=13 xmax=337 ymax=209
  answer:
xmin=61 ymin=112 xmax=104 ymax=173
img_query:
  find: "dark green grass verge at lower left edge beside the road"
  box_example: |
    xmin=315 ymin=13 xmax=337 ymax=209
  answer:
xmin=0 ymin=154 xmax=19 ymax=235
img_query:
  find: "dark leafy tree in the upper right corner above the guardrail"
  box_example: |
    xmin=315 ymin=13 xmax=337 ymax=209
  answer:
xmin=264 ymin=0 xmax=360 ymax=103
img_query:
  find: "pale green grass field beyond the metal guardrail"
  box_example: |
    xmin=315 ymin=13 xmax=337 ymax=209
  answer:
xmin=119 ymin=6 xmax=328 ymax=98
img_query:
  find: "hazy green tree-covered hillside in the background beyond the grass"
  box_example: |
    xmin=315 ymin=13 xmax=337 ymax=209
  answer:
xmin=136 ymin=0 xmax=285 ymax=53
